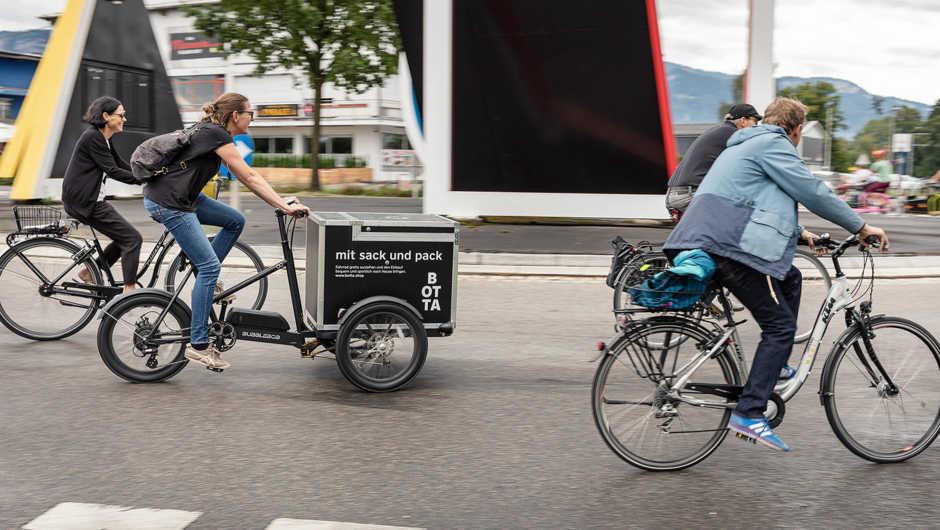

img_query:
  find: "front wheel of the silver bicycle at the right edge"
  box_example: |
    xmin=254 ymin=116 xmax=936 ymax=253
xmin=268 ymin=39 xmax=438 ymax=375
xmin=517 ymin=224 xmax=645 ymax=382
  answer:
xmin=822 ymin=317 xmax=940 ymax=463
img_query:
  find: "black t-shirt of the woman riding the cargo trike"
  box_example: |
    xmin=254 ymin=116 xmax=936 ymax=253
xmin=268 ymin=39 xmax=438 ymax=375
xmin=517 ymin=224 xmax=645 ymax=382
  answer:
xmin=144 ymin=123 xmax=232 ymax=212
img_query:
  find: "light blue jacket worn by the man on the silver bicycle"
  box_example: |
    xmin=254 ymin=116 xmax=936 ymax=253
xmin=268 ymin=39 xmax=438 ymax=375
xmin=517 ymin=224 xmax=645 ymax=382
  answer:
xmin=663 ymin=124 xmax=865 ymax=279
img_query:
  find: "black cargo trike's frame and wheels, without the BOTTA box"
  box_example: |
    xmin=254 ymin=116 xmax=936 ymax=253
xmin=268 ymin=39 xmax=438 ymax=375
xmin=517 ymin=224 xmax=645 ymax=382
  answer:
xmin=98 ymin=204 xmax=438 ymax=392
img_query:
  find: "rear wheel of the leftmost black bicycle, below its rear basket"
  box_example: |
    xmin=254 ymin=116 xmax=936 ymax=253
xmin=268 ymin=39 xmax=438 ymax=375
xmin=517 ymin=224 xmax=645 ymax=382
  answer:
xmin=0 ymin=237 xmax=102 ymax=340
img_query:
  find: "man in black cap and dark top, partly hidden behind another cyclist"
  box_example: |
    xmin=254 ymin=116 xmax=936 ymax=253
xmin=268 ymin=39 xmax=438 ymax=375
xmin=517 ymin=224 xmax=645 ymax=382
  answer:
xmin=666 ymin=103 xmax=763 ymax=222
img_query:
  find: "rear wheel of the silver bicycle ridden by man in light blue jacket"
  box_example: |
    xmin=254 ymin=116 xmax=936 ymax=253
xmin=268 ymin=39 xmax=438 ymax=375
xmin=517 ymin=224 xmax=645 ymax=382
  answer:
xmin=591 ymin=320 xmax=740 ymax=471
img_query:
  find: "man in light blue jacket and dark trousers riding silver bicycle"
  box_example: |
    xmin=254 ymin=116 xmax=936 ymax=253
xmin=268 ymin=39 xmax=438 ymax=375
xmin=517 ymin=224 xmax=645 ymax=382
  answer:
xmin=663 ymin=98 xmax=888 ymax=451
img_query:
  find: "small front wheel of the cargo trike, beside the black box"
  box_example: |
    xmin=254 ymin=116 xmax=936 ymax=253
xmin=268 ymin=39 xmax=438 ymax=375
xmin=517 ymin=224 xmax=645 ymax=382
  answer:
xmin=336 ymin=303 xmax=428 ymax=392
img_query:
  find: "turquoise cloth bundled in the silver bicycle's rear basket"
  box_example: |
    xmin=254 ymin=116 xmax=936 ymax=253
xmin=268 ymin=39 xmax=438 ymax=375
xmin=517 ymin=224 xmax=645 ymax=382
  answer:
xmin=627 ymin=249 xmax=715 ymax=309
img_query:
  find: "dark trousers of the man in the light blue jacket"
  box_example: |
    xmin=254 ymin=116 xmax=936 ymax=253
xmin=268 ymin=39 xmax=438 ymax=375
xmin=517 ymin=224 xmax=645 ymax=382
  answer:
xmin=712 ymin=255 xmax=803 ymax=419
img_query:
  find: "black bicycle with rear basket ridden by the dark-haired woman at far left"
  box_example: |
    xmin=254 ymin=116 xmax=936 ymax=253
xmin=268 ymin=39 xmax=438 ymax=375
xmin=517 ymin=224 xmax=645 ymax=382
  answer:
xmin=0 ymin=202 xmax=268 ymax=340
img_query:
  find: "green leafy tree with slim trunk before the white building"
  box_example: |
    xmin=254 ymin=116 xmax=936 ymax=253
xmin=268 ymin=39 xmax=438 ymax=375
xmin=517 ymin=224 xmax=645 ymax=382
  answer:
xmin=184 ymin=0 xmax=401 ymax=191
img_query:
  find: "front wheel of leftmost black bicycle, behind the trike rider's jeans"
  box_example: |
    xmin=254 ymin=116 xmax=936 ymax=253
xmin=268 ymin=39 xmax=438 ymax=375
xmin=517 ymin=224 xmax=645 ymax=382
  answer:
xmin=165 ymin=236 xmax=268 ymax=309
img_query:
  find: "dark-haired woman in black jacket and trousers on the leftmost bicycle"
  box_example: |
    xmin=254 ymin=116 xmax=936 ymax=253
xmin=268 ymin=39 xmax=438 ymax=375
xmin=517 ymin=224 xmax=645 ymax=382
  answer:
xmin=62 ymin=96 xmax=143 ymax=292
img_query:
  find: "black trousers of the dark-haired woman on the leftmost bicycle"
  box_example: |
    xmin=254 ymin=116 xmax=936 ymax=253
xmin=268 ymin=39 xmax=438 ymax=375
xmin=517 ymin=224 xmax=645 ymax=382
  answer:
xmin=65 ymin=201 xmax=143 ymax=285
